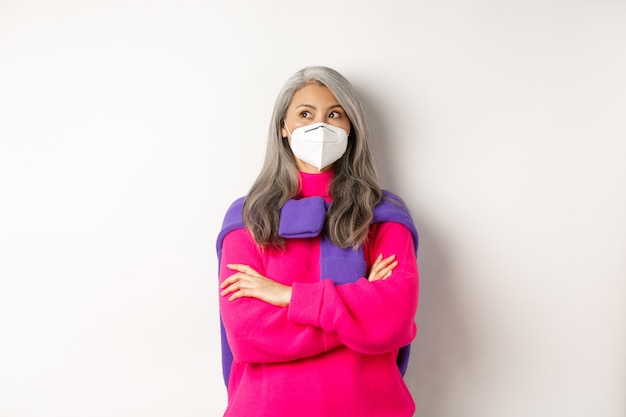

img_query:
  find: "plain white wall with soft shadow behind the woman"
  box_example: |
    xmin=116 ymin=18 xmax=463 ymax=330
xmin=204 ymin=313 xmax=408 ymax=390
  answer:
xmin=0 ymin=0 xmax=626 ymax=417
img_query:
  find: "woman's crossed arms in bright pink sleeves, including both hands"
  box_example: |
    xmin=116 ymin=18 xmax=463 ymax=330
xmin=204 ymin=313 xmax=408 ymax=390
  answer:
xmin=220 ymin=224 xmax=419 ymax=363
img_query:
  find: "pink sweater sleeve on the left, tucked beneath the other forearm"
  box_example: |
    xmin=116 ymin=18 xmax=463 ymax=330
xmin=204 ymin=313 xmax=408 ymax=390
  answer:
xmin=220 ymin=229 xmax=341 ymax=363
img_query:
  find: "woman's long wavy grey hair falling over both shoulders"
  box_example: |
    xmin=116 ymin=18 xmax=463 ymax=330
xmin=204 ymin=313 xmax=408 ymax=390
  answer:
xmin=243 ymin=66 xmax=382 ymax=248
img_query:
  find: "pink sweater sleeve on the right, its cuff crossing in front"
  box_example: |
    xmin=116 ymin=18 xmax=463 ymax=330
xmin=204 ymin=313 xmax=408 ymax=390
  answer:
xmin=288 ymin=222 xmax=419 ymax=354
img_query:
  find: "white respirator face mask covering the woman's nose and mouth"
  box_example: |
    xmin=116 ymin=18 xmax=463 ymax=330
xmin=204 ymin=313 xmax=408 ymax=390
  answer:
xmin=285 ymin=122 xmax=348 ymax=171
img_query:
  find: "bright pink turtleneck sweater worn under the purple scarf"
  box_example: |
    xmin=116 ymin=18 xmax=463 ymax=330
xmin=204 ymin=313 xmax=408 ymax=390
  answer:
xmin=220 ymin=173 xmax=419 ymax=417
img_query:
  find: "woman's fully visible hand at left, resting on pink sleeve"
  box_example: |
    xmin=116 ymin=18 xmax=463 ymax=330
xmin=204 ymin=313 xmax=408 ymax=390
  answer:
xmin=220 ymin=264 xmax=291 ymax=307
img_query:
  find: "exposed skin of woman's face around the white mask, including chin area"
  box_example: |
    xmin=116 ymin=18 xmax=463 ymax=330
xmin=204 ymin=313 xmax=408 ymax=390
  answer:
xmin=281 ymin=84 xmax=351 ymax=173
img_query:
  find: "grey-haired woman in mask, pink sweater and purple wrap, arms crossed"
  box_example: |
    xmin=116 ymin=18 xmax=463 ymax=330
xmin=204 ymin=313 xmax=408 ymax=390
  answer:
xmin=217 ymin=67 xmax=418 ymax=417
